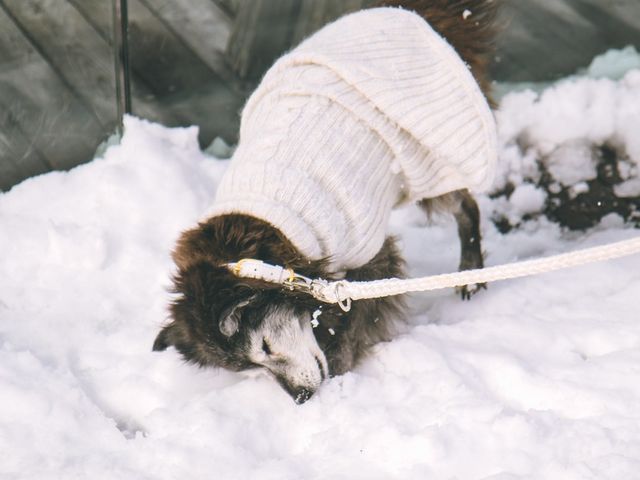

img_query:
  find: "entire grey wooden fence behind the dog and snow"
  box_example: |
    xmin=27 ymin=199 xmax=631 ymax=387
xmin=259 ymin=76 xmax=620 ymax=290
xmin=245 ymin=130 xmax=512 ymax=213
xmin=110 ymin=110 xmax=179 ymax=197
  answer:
xmin=0 ymin=0 xmax=640 ymax=190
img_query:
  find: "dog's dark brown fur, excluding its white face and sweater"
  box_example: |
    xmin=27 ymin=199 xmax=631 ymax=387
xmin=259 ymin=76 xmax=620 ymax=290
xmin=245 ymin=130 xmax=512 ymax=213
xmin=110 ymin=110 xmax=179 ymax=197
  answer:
xmin=153 ymin=0 xmax=495 ymax=399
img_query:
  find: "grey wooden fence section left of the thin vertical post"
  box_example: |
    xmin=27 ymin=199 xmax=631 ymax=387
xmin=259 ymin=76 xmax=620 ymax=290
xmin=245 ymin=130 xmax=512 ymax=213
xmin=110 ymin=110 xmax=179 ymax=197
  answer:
xmin=0 ymin=0 xmax=117 ymax=190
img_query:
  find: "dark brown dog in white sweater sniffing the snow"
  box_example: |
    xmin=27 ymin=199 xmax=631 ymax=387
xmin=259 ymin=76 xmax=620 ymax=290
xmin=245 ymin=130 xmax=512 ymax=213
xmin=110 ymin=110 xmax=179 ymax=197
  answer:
xmin=153 ymin=0 xmax=496 ymax=403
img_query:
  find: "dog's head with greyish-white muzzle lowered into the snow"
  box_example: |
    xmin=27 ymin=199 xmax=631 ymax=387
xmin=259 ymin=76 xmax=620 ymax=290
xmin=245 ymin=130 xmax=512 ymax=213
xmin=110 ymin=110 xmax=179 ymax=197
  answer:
xmin=153 ymin=216 xmax=329 ymax=403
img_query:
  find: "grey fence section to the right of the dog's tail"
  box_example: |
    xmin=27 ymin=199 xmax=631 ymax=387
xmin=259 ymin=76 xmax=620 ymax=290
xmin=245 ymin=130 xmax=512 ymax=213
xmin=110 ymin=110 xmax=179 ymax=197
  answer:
xmin=491 ymin=0 xmax=640 ymax=82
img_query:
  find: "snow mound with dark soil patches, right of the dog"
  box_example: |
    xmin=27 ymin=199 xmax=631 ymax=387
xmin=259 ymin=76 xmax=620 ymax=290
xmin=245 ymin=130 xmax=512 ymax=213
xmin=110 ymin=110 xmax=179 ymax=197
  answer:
xmin=493 ymin=51 xmax=640 ymax=230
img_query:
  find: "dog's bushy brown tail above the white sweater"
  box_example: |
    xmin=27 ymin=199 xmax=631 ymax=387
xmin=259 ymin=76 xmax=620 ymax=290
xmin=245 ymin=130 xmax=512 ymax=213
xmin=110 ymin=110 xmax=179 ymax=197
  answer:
xmin=380 ymin=0 xmax=500 ymax=98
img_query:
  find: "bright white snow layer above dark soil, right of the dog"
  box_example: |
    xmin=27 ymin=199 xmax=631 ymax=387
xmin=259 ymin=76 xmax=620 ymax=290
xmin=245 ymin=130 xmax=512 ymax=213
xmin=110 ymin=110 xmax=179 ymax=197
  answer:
xmin=498 ymin=69 xmax=640 ymax=188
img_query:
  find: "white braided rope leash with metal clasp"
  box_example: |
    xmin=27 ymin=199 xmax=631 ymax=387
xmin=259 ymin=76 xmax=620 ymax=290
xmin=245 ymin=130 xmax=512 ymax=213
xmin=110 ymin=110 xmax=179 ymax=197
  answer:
xmin=228 ymin=237 xmax=640 ymax=310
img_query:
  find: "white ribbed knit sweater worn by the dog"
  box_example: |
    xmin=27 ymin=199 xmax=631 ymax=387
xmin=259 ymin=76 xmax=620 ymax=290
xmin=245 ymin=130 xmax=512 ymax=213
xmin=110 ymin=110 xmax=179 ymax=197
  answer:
xmin=209 ymin=8 xmax=496 ymax=271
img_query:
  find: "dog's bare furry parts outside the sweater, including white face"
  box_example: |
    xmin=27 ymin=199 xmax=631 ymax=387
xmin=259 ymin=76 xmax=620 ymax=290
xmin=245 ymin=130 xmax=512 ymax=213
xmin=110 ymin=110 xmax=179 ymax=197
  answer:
xmin=153 ymin=0 xmax=495 ymax=403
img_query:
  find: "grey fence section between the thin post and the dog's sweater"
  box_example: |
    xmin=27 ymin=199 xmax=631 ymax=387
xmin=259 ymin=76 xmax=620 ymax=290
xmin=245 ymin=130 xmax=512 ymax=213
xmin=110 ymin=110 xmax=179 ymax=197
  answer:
xmin=108 ymin=0 xmax=371 ymax=148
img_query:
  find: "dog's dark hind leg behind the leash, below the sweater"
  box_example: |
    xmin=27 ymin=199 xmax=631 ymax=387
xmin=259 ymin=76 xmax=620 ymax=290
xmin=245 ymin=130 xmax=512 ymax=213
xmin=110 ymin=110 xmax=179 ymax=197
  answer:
xmin=419 ymin=190 xmax=487 ymax=300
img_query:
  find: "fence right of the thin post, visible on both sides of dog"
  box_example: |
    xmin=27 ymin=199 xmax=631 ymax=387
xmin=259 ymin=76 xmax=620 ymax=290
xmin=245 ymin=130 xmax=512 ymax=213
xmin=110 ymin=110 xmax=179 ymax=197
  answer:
xmin=110 ymin=0 xmax=640 ymax=147
